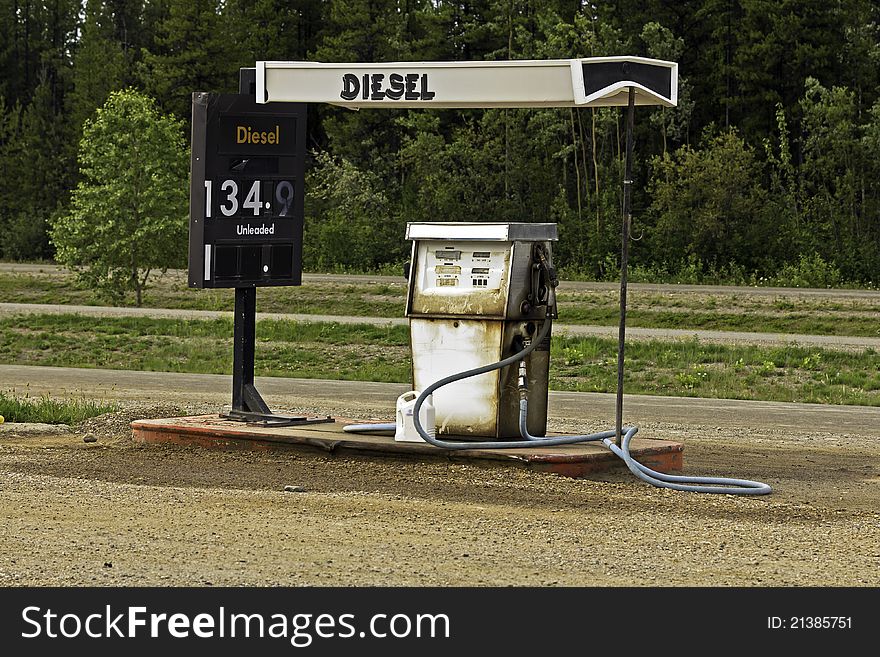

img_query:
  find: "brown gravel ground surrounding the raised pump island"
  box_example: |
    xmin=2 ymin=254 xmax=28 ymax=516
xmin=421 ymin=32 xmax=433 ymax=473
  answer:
xmin=0 ymin=366 xmax=880 ymax=586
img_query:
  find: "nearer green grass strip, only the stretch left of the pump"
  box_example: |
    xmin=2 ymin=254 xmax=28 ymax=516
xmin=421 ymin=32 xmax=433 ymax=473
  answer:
xmin=0 ymin=315 xmax=410 ymax=381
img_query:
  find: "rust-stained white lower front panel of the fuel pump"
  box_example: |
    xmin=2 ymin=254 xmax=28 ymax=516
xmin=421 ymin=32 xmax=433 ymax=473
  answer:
xmin=410 ymin=318 xmax=504 ymax=438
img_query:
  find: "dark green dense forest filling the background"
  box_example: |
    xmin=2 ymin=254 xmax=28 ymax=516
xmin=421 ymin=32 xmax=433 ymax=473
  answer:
xmin=0 ymin=0 xmax=880 ymax=287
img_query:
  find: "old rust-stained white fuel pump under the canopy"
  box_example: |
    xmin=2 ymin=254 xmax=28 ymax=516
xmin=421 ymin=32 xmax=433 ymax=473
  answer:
xmin=406 ymin=222 xmax=558 ymax=440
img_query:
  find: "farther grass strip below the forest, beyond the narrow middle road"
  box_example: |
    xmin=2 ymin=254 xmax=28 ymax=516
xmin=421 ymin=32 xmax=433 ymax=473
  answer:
xmin=0 ymin=268 xmax=880 ymax=337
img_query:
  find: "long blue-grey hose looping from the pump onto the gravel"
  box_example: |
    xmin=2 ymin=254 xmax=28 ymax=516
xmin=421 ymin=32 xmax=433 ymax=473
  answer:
xmin=343 ymin=319 xmax=772 ymax=495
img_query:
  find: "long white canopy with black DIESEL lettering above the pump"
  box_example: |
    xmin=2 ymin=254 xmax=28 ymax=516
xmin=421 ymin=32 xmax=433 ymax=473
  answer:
xmin=256 ymin=57 xmax=678 ymax=108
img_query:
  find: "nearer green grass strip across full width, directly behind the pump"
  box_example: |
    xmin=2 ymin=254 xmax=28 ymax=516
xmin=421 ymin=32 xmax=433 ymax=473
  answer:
xmin=0 ymin=315 xmax=880 ymax=406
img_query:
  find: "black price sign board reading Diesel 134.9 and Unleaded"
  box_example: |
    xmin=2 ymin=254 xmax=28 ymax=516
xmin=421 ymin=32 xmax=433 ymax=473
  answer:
xmin=189 ymin=92 xmax=306 ymax=288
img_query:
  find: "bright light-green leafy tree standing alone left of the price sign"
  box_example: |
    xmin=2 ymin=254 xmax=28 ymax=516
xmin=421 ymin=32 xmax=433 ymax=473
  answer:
xmin=51 ymin=89 xmax=188 ymax=306
